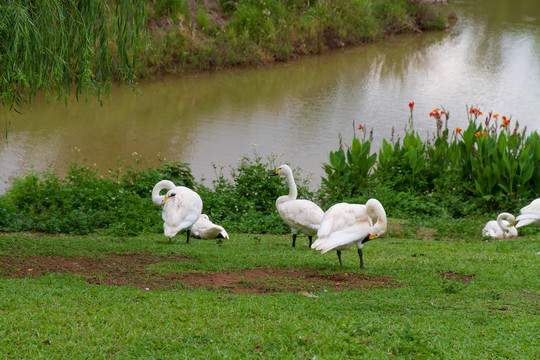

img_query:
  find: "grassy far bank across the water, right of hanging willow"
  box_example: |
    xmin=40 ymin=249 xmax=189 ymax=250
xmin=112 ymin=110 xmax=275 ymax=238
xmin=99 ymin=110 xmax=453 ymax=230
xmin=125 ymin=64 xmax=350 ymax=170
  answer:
xmin=135 ymin=0 xmax=452 ymax=78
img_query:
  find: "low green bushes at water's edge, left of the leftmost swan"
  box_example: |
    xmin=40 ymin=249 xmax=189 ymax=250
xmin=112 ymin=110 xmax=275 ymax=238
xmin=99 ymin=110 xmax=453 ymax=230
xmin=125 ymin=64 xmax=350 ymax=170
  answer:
xmin=0 ymin=163 xmax=194 ymax=235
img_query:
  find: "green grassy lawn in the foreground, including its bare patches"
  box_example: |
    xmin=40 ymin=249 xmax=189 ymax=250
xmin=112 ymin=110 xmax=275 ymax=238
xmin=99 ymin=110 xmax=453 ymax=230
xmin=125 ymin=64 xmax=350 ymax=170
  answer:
xmin=0 ymin=224 xmax=540 ymax=359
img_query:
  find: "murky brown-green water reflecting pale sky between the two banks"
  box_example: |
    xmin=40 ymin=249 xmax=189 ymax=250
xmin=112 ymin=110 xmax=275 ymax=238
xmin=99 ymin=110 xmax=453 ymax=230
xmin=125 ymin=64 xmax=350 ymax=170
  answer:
xmin=0 ymin=0 xmax=540 ymax=192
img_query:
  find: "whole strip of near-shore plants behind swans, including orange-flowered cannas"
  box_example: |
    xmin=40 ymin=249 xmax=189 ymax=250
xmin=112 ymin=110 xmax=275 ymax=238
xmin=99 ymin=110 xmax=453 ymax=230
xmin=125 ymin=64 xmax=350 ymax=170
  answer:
xmin=0 ymin=102 xmax=540 ymax=239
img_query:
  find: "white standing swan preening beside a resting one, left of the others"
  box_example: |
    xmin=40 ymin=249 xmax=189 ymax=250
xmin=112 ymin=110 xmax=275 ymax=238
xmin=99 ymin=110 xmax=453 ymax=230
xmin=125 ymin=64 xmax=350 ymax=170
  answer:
xmin=152 ymin=180 xmax=202 ymax=243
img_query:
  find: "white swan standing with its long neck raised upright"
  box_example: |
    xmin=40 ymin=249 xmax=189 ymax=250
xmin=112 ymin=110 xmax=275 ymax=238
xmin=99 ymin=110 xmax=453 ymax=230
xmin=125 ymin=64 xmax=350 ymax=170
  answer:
xmin=270 ymin=165 xmax=324 ymax=247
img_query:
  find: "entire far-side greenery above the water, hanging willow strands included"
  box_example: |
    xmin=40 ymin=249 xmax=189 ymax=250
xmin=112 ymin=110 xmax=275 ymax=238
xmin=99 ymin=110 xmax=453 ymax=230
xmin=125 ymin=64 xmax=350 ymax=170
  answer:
xmin=0 ymin=0 xmax=446 ymax=111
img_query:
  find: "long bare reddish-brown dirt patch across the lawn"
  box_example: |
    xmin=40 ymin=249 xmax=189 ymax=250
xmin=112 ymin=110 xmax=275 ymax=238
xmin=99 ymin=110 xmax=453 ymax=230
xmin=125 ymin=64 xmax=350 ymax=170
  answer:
xmin=0 ymin=253 xmax=397 ymax=294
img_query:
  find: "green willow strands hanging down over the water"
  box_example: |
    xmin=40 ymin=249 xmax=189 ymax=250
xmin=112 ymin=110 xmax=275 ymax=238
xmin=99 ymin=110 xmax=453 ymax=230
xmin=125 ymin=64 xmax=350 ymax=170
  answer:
xmin=0 ymin=0 xmax=144 ymax=110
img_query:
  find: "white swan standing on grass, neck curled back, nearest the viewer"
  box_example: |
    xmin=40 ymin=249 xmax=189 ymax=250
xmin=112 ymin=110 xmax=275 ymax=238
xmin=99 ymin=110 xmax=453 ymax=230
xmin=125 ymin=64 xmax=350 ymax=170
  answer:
xmin=311 ymin=199 xmax=387 ymax=269
